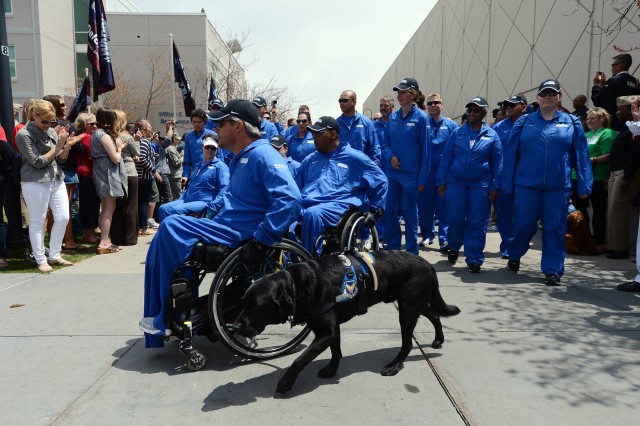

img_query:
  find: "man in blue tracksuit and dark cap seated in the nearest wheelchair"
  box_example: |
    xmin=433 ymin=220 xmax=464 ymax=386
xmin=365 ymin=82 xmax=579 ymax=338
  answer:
xmin=140 ymin=99 xmax=300 ymax=347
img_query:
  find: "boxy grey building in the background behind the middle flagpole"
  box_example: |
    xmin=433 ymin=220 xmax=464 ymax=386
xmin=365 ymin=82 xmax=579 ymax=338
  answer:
xmin=108 ymin=13 xmax=244 ymax=133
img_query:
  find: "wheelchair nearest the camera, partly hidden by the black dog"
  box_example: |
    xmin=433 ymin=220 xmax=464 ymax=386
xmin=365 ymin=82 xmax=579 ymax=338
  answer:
xmin=165 ymin=239 xmax=311 ymax=371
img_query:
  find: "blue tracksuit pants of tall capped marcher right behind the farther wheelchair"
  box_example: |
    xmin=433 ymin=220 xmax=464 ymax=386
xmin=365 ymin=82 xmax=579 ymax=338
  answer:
xmin=384 ymin=177 xmax=418 ymax=254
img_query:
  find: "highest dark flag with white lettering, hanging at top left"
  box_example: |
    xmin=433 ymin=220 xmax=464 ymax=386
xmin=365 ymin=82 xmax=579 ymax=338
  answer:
xmin=87 ymin=0 xmax=116 ymax=101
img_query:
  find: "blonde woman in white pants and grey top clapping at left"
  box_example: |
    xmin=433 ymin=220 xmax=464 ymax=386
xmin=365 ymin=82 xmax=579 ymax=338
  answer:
xmin=16 ymin=100 xmax=80 ymax=272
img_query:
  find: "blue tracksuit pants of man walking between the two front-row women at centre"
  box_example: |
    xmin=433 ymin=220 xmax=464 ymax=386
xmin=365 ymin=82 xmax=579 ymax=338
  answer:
xmin=418 ymin=176 xmax=449 ymax=246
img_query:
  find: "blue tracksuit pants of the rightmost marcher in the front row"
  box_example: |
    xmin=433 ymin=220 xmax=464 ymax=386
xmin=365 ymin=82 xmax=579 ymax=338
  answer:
xmin=508 ymin=186 xmax=571 ymax=276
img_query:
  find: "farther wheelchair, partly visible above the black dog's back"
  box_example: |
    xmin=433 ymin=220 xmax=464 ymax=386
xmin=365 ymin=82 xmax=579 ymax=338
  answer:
xmin=313 ymin=207 xmax=380 ymax=256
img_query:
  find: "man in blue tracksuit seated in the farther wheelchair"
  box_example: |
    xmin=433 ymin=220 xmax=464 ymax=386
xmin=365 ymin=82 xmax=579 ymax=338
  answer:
xmin=296 ymin=116 xmax=387 ymax=256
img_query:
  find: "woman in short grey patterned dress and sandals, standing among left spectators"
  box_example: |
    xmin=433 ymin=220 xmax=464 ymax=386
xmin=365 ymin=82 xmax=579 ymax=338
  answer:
xmin=91 ymin=108 xmax=127 ymax=254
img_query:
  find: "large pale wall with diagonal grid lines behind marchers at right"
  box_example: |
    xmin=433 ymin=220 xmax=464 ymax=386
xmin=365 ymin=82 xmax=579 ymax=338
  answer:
xmin=363 ymin=0 xmax=640 ymax=117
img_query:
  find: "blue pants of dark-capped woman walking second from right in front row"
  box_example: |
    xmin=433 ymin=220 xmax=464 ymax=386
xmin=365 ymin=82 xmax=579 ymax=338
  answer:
xmin=445 ymin=184 xmax=491 ymax=265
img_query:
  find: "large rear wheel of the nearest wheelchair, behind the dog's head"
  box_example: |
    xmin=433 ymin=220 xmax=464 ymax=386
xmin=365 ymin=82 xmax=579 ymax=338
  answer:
xmin=208 ymin=240 xmax=311 ymax=359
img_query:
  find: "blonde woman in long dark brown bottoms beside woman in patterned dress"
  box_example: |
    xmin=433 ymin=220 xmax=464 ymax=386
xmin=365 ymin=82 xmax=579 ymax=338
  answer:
xmin=111 ymin=109 xmax=140 ymax=246
